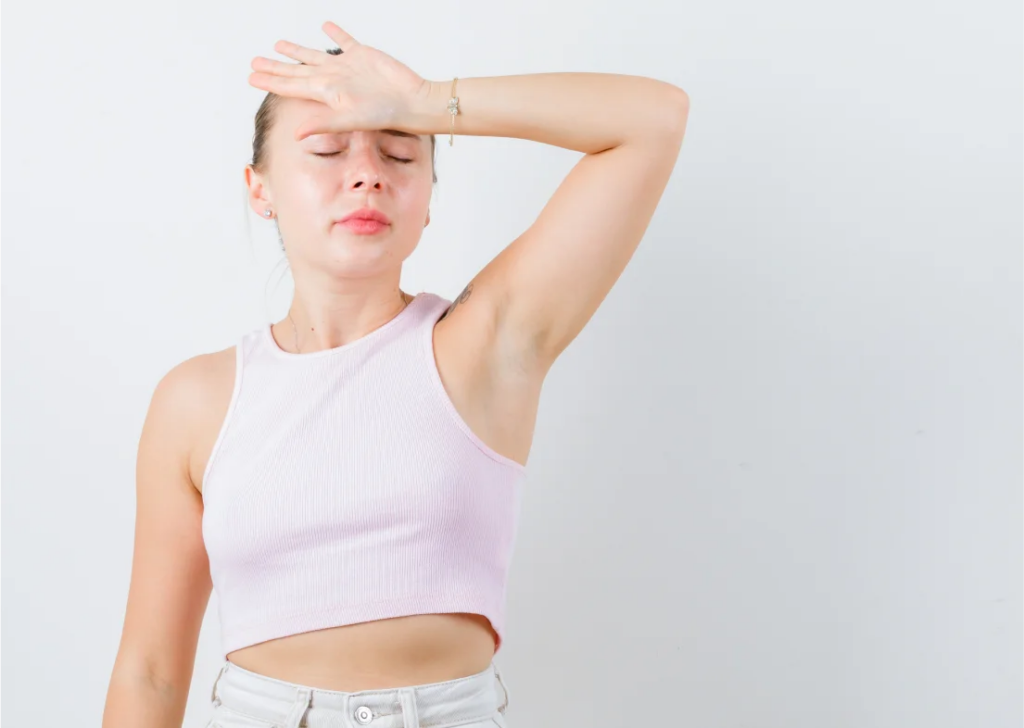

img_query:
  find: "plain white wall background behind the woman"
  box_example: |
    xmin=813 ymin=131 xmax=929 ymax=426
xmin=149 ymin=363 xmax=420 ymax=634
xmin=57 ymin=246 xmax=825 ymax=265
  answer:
xmin=0 ymin=0 xmax=1024 ymax=728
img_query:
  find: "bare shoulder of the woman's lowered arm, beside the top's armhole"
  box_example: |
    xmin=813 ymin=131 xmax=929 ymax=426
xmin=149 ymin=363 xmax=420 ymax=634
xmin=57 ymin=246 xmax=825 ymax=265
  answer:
xmin=153 ymin=345 xmax=236 ymax=493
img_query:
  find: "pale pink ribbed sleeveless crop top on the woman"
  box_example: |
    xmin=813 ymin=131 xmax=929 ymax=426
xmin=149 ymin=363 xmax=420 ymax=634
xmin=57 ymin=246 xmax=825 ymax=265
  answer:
xmin=203 ymin=292 xmax=525 ymax=657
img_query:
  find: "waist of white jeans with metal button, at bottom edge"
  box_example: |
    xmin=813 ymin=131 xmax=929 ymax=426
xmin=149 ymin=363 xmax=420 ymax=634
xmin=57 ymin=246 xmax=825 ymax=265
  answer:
xmin=206 ymin=660 xmax=509 ymax=728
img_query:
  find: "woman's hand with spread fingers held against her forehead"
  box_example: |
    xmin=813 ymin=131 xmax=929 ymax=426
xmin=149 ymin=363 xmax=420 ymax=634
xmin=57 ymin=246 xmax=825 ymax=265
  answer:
xmin=249 ymin=20 xmax=430 ymax=141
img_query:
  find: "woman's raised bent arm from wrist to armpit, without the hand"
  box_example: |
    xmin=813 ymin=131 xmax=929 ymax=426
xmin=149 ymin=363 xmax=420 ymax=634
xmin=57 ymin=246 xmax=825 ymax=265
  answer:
xmin=402 ymin=73 xmax=689 ymax=368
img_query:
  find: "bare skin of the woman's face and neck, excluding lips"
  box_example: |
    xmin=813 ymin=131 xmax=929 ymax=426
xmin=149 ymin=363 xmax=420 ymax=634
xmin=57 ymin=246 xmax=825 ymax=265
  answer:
xmin=246 ymin=98 xmax=432 ymax=351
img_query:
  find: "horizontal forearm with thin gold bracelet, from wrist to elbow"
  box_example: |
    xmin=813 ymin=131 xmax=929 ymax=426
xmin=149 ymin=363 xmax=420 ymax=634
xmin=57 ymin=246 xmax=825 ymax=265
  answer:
xmin=403 ymin=73 xmax=689 ymax=154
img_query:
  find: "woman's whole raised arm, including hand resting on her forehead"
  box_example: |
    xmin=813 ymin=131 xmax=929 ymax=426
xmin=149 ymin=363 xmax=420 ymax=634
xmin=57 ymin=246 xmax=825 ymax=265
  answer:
xmin=250 ymin=23 xmax=690 ymax=366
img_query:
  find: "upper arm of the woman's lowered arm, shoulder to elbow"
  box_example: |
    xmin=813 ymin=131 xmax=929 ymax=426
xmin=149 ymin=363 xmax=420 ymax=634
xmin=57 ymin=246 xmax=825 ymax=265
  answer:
xmin=109 ymin=357 xmax=212 ymax=710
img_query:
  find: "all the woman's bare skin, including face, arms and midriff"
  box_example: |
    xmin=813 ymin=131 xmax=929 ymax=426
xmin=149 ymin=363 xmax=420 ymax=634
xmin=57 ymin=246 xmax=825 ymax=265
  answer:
xmin=103 ymin=26 xmax=688 ymax=728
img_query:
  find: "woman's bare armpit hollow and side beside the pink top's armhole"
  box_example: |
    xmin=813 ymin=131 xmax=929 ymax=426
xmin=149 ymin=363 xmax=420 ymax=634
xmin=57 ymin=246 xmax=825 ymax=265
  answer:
xmin=433 ymin=280 xmax=547 ymax=466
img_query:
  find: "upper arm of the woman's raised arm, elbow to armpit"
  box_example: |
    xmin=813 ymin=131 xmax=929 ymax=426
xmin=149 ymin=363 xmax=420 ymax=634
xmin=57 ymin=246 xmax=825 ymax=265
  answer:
xmin=474 ymin=89 xmax=689 ymax=366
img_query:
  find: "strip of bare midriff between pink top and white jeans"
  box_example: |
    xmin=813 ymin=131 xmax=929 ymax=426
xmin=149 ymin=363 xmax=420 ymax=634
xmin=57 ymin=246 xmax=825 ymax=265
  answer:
xmin=227 ymin=613 xmax=496 ymax=692
